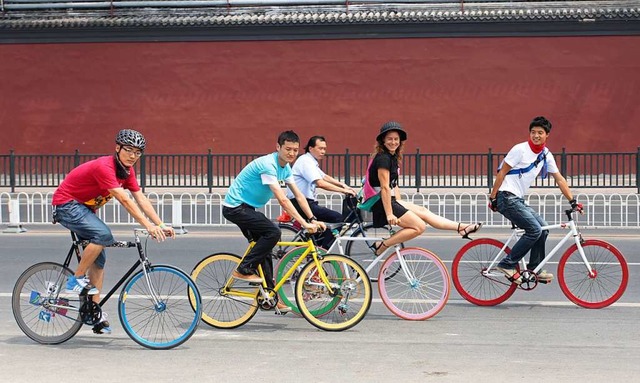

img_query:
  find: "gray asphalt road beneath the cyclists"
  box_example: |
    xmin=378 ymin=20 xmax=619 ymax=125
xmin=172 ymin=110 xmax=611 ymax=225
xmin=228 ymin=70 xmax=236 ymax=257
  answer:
xmin=0 ymin=227 xmax=640 ymax=382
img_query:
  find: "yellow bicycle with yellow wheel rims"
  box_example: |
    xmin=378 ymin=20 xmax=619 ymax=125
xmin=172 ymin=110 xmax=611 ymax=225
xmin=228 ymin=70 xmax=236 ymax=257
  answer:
xmin=191 ymin=231 xmax=372 ymax=331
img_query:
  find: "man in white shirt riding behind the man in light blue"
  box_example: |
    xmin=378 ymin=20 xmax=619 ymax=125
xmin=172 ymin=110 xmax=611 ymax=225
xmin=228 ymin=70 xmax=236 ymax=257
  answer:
xmin=287 ymin=136 xmax=357 ymax=249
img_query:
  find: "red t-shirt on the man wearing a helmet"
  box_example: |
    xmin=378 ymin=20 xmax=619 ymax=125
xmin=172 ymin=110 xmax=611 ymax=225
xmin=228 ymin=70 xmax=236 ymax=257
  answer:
xmin=52 ymin=156 xmax=140 ymax=210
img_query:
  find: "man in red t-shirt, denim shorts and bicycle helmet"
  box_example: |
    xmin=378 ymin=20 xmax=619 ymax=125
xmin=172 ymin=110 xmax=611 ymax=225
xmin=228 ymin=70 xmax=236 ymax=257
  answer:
xmin=52 ymin=129 xmax=175 ymax=334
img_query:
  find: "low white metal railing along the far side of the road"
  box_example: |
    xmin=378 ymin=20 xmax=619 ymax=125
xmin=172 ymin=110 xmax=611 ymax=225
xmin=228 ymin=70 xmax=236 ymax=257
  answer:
xmin=0 ymin=192 xmax=640 ymax=228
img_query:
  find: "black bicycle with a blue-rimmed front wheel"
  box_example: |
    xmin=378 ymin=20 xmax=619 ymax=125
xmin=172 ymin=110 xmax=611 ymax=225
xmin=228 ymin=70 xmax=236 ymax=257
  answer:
xmin=11 ymin=229 xmax=202 ymax=349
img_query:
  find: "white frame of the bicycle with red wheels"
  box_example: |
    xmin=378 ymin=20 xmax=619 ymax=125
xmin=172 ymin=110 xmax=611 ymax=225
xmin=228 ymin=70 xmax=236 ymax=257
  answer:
xmin=482 ymin=216 xmax=593 ymax=276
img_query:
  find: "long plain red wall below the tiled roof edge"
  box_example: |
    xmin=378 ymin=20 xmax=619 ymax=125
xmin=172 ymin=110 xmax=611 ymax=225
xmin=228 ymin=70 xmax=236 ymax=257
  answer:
xmin=0 ymin=37 xmax=640 ymax=154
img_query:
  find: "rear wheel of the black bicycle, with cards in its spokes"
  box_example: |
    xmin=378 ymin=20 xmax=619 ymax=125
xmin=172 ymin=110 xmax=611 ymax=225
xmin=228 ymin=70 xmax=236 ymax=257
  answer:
xmin=11 ymin=262 xmax=82 ymax=344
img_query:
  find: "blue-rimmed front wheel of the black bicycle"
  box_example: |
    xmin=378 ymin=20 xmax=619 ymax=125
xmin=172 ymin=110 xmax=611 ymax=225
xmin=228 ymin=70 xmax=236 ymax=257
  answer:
xmin=118 ymin=265 xmax=202 ymax=350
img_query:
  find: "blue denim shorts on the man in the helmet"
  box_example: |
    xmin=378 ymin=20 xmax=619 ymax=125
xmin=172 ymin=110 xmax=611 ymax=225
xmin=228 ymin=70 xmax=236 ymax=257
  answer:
xmin=53 ymin=201 xmax=115 ymax=269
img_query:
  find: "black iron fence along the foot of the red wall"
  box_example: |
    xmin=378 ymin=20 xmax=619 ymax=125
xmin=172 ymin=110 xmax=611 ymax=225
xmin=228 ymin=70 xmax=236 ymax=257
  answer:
xmin=0 ymin=147 xmax=640 ymax=193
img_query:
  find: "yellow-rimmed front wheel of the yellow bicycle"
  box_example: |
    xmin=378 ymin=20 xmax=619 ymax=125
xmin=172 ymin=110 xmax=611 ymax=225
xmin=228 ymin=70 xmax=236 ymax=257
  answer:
xmin=296 ymin=254 xmax=372 ymax=331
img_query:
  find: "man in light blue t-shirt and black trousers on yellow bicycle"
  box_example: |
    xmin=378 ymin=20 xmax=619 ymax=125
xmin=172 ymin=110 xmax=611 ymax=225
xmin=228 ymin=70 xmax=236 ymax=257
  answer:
xmin=222 ymin=130 xmax=326 ymax=313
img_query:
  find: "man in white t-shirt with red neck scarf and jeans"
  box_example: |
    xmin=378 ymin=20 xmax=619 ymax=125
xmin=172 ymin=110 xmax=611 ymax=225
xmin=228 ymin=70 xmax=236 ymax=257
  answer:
xmin=489 ymin=116 xmax=582 ymax=284
